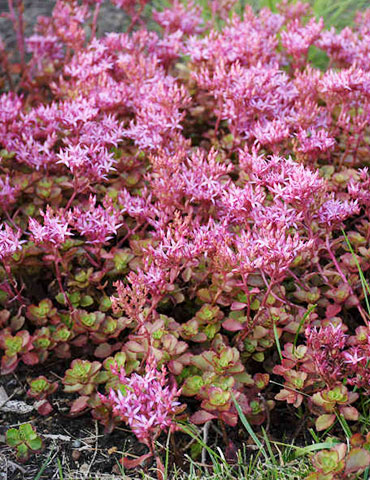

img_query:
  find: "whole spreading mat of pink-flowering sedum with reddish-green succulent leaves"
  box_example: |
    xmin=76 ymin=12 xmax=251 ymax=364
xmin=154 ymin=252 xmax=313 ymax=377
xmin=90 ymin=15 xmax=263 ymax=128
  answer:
xmin=0 ymin=0 xmax=370 ymax=480
